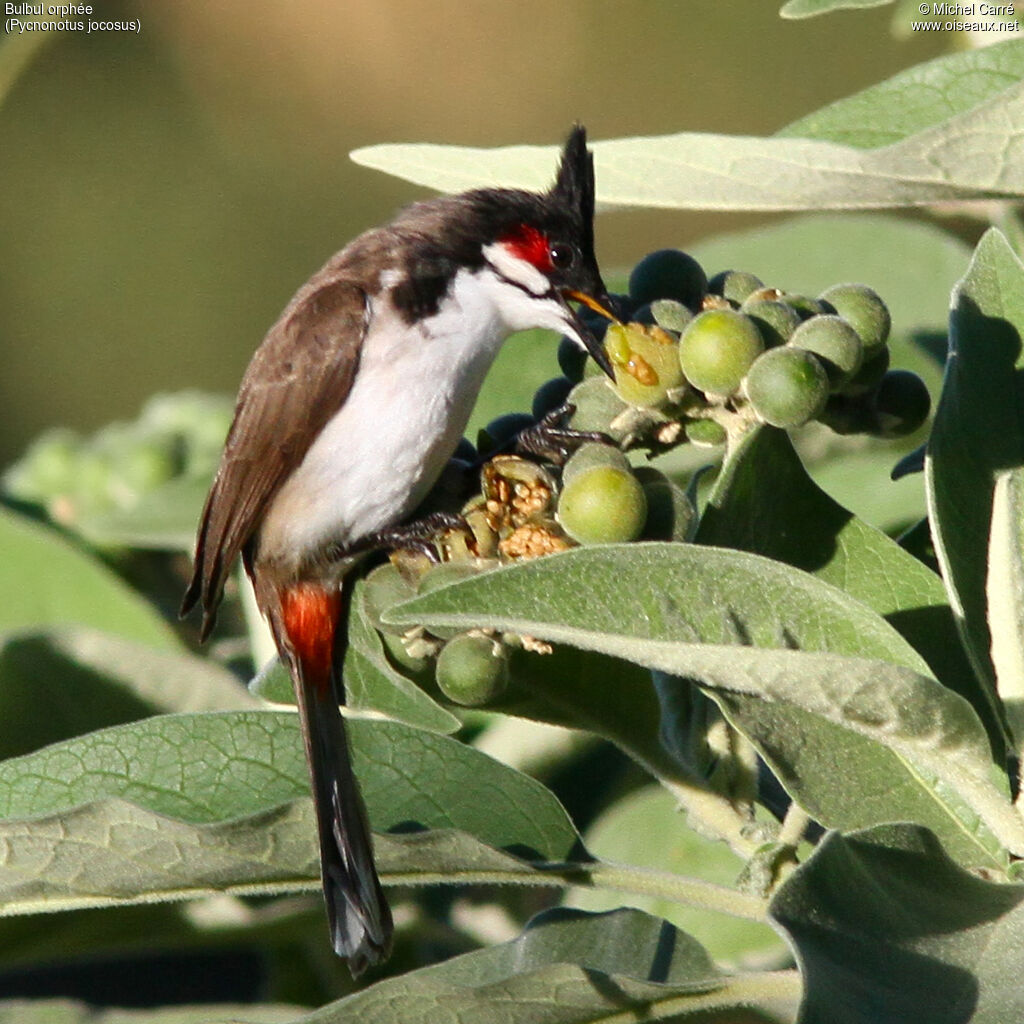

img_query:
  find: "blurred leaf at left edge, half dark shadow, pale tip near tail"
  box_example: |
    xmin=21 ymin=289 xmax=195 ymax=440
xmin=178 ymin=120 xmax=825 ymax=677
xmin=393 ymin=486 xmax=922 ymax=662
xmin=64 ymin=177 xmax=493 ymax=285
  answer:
xmin=0 ymin=627 xmax=258 ymax=758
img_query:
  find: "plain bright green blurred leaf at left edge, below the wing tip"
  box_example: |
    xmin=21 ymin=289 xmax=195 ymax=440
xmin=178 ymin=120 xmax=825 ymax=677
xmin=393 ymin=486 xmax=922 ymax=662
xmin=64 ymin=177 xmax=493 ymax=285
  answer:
xmin=0 ymin=508 xmax=181 ymax=650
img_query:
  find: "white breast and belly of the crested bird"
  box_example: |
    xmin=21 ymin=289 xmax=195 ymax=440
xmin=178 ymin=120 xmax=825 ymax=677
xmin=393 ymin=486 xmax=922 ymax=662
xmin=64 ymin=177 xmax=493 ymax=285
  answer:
xmin=260 ymin=271 xmax=510 ymax=564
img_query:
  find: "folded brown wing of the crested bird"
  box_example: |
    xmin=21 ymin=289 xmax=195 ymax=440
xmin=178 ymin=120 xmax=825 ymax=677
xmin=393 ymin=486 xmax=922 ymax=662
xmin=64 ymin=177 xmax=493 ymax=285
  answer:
xmin=181 ymin=272 xmax=369 ymax=639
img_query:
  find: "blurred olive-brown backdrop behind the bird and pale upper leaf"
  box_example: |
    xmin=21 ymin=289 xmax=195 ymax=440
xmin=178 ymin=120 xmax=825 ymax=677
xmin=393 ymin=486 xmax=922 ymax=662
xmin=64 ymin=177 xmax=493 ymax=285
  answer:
xmin=0 ymin=0 xmax=947 ymax=466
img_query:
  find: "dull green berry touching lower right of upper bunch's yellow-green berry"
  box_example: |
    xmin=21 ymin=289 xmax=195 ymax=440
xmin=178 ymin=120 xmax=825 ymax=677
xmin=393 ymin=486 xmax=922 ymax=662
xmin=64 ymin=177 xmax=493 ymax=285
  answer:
xmin=744 ymin=345 xmax=828 ymax=427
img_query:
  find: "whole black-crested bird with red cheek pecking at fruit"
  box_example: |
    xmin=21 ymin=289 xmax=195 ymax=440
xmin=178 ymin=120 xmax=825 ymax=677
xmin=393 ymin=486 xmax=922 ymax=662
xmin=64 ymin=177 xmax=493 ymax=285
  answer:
xmin=182 ymin=127 xmax=610 ymax=975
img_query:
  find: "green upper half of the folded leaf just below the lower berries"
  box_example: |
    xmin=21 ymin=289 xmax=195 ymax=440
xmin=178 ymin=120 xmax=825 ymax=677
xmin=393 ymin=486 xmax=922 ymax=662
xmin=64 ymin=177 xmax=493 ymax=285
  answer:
xmin=385 ymin=543 xmax=927 ymax=672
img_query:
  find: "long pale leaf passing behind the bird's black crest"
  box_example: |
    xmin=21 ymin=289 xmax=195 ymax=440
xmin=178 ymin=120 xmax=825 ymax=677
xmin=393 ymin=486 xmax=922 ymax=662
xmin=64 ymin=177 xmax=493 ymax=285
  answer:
xmin=351 ymin=76 xmax=1024 ymax=211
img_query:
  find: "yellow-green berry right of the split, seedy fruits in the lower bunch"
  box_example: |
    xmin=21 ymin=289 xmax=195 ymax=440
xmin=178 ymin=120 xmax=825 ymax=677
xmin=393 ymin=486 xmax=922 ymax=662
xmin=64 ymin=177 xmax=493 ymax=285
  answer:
xmin=558 ymin=466 xmax=647 ymax=544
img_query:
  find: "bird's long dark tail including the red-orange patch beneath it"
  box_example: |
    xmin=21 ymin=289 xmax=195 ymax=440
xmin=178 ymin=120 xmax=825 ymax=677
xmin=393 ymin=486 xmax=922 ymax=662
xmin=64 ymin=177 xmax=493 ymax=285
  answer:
xmin=279 ymin=584 xmax=393 ymax=977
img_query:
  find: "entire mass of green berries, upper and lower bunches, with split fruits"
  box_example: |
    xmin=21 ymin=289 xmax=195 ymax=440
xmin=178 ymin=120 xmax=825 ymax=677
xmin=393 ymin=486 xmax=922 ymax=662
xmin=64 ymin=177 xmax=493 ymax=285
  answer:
xmin=366 ymin=250 xmax=929 ymax=706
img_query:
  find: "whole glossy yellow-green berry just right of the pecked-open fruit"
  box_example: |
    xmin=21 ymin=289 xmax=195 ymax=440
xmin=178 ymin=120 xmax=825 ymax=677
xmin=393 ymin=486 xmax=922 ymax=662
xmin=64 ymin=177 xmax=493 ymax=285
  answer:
xmin=679 ymin=309 xmax=764 ymax=394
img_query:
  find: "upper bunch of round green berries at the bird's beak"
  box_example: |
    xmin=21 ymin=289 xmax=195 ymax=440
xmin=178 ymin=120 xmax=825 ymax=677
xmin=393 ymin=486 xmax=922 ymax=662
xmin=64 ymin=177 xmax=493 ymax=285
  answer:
xmin=565 ymin=249 xmax=929 ymax=451
